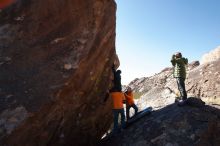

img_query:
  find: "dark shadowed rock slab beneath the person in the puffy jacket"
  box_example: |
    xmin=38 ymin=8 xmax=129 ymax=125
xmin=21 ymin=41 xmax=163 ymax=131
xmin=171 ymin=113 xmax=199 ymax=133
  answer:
xmin=100 ymin=98 xmax=220 ymax=146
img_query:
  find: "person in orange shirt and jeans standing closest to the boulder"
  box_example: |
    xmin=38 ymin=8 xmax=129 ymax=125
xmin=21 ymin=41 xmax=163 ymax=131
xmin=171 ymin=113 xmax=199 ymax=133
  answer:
xmin=110 ymin=92 xmax=125 ymax=133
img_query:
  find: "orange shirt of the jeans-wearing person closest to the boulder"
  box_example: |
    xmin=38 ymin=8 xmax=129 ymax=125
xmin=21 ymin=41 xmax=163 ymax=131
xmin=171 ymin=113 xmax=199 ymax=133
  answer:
xmin=111 ymin=92 xmax=125 ymax=109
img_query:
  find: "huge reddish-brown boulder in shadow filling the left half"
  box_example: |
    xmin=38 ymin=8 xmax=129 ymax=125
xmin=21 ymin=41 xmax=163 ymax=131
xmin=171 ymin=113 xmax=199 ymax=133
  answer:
xmin=0 ymin=0 xmax=116 ymax=146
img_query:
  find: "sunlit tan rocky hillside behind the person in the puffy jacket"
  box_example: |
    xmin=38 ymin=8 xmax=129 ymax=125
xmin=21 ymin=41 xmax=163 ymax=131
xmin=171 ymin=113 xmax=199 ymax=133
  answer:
xmin=129 ymin=48 xmax=220 ymax=109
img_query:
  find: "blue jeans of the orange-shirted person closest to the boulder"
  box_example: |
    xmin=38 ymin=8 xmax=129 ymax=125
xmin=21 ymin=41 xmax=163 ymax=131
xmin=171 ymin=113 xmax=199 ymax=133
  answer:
xmin=112 ymin=108 xmax=125 ymax=133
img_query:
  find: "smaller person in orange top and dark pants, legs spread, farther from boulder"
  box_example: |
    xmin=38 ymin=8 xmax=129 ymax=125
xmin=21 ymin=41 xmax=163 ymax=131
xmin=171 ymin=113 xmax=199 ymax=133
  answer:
xmin=124 ymin=87 xmax=138 ymax=120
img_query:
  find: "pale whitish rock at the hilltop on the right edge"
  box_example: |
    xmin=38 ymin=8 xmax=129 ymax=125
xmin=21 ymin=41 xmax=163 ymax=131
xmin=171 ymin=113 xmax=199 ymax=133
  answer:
xmin=201 ymin=46 xmax=220 ymax=64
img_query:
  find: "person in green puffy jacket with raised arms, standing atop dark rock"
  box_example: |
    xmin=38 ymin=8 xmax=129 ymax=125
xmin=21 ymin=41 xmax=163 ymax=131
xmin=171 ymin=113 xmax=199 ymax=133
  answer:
xmin=171 ymin=52 xmax=188 ymax=104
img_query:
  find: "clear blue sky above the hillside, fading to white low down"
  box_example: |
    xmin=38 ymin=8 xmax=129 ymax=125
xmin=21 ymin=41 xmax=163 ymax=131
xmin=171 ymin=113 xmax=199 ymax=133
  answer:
xmin=116 ymin=0 xmax=220 ymax=84
